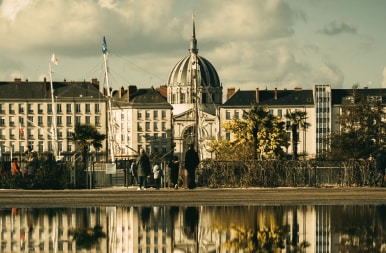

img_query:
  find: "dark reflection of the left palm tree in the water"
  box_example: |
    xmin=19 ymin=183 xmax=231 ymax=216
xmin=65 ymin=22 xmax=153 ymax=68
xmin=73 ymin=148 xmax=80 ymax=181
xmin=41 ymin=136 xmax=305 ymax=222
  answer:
xmin=69 ymin=225 xmax=106 ymax=249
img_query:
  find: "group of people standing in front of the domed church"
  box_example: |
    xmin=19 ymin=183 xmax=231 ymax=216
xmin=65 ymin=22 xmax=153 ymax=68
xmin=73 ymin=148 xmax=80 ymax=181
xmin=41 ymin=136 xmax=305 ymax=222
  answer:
xmin=130 ymin=144 xmax=200 ymax=191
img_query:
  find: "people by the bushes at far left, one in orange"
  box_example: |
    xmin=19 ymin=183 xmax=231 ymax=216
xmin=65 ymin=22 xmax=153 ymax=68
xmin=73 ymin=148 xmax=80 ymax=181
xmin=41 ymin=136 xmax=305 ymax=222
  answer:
xmin=11 ymin=146 xmax=38 ymax=179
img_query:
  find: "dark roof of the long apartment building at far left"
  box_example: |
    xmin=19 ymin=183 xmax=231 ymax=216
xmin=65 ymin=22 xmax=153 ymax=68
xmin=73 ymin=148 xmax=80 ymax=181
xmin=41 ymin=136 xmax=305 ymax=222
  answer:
xmin=0 ymin=79 xmax=102 ymax=100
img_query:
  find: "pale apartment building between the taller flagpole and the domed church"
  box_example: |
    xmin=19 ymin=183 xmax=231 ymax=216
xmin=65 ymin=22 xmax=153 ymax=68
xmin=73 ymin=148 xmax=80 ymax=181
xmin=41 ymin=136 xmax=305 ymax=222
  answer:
xmin=112 ymin=86 xmax=173 ymax=159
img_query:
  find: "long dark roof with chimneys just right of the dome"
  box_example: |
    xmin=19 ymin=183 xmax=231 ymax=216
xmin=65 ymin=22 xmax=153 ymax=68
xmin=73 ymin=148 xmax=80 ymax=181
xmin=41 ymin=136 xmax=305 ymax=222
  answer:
xmin=221 ymin=89 xmax=314 ymax=107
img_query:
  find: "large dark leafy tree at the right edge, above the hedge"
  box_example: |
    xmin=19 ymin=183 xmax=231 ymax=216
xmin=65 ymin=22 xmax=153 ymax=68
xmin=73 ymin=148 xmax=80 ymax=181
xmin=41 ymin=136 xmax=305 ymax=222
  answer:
xmin=329 ymin=87 xmax=386 ymax=159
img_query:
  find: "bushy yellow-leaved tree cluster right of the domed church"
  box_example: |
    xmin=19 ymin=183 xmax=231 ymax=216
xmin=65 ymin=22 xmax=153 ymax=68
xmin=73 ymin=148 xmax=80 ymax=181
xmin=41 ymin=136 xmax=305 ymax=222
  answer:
xmin=211 ymin=105 xmax=286 ymax=160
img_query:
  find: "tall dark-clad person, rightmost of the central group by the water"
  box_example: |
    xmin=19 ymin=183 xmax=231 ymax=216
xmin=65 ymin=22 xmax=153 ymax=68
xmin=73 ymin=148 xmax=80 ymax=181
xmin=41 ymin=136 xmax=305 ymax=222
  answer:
xmin=184 ymin=144 xmax=200 ymax=189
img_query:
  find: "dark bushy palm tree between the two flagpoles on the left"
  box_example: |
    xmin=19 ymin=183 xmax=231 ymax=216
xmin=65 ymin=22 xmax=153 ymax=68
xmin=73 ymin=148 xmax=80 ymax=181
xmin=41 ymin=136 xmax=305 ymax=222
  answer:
xmin=68 ymin=124 xmax=106 ymax=169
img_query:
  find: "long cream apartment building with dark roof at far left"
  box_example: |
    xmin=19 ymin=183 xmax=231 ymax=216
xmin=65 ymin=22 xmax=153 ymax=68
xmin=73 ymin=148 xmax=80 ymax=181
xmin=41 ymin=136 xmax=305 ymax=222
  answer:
xmin=0 ymin=79 xmax=107 ymax=158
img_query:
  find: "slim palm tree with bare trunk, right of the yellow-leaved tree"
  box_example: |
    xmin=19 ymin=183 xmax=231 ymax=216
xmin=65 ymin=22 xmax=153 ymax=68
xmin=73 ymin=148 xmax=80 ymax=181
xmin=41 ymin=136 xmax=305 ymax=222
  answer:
xmin=285 ymin=111 xmax=311 ymax=160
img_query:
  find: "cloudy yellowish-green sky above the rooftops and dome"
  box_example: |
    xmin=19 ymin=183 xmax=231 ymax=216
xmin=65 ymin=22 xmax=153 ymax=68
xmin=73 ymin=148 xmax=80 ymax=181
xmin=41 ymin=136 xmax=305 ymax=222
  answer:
xmin=0 ymin=0 xmax=386 ymax=93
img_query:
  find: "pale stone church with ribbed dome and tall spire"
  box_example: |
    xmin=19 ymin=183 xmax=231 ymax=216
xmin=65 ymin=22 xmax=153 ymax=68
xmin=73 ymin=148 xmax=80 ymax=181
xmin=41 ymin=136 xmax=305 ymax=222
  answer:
xmin=167 ymin=19 xmax=222 ymax=159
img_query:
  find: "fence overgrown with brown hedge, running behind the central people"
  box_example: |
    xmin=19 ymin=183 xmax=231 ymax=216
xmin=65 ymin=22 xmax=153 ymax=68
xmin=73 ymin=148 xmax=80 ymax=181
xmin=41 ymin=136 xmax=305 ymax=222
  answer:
xmin=87 ymin=160 xmax=376 ymax=188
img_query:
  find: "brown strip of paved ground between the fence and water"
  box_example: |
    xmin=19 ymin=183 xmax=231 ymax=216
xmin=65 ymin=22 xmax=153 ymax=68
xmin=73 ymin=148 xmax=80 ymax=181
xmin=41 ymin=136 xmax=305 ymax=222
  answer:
xmin=0 ymin=187 xmax=386 ymax=208
